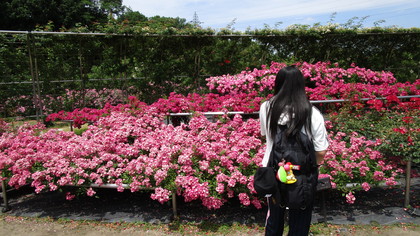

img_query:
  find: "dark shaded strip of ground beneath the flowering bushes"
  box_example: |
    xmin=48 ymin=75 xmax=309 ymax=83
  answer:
xmin=1 ymin=181 xmax=420 ymax=226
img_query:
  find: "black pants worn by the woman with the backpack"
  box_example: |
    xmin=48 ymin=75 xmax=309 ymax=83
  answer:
xmin=265 ymin=198 xmax=313 ymax=236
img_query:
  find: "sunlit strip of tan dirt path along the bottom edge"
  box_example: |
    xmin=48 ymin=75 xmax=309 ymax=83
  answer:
xmin=0 ymin=216 xmax=420 ymax=236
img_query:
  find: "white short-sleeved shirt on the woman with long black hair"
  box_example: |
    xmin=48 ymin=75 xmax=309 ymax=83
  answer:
xmin=260 ymin=101 xmax=329 ymax=166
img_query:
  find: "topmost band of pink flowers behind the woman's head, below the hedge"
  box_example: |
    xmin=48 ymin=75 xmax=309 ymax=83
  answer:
xmin=207 ymin=62 xmax=396 ymax=96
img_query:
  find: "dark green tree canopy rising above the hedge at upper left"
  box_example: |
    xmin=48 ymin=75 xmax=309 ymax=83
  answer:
xmin=0 ymin=0 xmax=192 ymax=31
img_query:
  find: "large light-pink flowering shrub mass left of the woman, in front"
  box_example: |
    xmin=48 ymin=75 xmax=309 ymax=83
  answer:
xmin=0 ymin=109 xmax=263 ymax=209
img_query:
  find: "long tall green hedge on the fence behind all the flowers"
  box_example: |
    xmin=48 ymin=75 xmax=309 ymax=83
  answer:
xmin=0 ymin=23 xmax=420 ymax=105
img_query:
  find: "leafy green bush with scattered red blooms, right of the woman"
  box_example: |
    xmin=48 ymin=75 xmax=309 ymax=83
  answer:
xmin=330 ymin=96 xmax=420 ymax=163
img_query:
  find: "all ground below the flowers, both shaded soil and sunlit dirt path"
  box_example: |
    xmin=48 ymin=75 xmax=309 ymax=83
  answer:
xmin=0 ymin=178 xmax=420 ymax=236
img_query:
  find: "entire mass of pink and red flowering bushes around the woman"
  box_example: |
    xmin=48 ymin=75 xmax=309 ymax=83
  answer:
xmin=0 ymin=63 xmax=420 ymax=209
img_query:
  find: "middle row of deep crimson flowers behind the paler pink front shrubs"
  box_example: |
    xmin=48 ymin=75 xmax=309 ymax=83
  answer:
xmin=46 ymin=80 xmax=420 ymax=126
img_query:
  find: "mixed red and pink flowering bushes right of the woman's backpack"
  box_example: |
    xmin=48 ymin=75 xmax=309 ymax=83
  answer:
xmin=323 ymin=96 xmax=420 ymax=202
